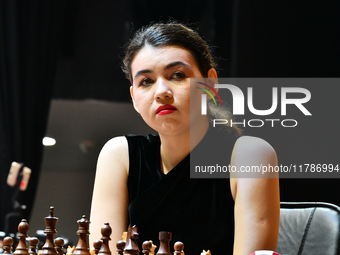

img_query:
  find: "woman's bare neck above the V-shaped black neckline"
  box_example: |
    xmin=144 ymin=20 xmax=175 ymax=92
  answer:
xmin=159 ymin=121 xmax=209 ymax=174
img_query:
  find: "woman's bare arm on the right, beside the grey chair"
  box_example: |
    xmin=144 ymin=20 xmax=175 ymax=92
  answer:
xmin=231 ymin=136 xmax=280 ymax=255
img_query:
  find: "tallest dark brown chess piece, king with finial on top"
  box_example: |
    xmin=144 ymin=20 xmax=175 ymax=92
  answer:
xmin=39 ymin=206 xmax=58 ymax=255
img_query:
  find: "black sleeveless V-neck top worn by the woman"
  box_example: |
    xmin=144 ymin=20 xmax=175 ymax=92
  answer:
xmin=126 ymin=128 xmax=236 ymax=255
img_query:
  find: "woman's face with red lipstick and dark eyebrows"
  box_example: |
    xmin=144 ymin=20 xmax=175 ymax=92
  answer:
xmin=130 ymin=45 xmax=216 ymax=134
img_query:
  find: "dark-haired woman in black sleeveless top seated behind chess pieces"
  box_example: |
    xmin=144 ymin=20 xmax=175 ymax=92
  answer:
xmin=91 ymin=23 xmax=279 ymax=255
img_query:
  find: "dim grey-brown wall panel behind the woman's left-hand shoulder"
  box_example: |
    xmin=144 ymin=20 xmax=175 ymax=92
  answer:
xmin=28 ymin=100 xmax=155 ymax=245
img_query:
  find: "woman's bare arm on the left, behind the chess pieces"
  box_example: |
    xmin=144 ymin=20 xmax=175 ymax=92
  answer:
xmin=89 ymin=137 xmax=129 ymax=247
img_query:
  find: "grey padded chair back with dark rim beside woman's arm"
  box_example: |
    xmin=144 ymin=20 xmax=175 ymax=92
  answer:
xmin=277 ymin=202 xmax=340 ymax=255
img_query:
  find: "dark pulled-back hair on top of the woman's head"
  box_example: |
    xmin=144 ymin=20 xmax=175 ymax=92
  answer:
xmin=122 ymin=23 xmax=217 ymax=83
